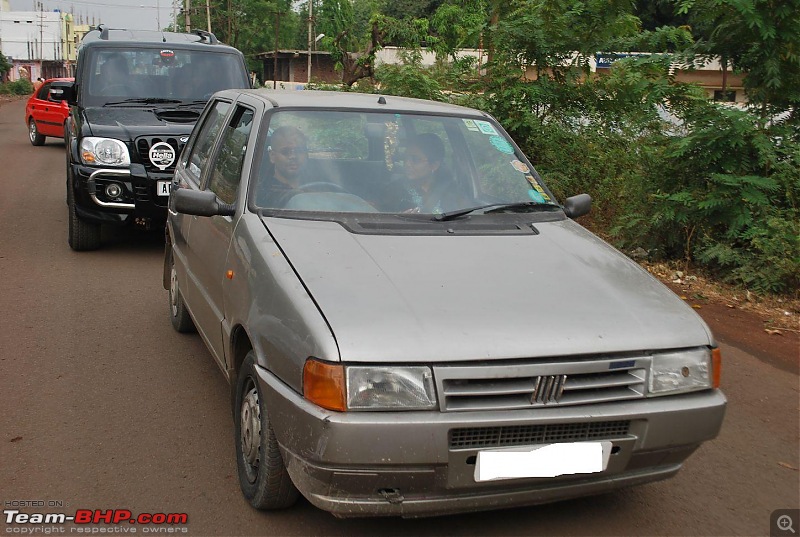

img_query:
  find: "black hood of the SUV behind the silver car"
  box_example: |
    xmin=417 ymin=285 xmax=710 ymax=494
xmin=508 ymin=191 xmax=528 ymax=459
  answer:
xmin=83 ymin=106 xmax=198 ymax=141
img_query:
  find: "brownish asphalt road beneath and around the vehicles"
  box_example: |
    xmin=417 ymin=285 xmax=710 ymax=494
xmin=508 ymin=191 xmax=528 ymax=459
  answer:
xmin=0 ymin=97 xmax=800 ymax=536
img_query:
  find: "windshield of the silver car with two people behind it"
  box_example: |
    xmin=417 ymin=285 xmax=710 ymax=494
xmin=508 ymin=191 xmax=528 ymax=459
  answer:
xmin=251 ymin=110 xmax=557 ymax=220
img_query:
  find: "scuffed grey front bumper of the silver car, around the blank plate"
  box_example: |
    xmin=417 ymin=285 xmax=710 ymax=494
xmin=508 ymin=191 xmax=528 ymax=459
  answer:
xmin=258 ymin=368 xmax=726 ymax=517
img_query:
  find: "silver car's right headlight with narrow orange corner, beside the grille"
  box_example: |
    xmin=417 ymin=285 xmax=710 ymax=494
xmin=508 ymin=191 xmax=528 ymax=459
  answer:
xmin=650 ymin=348 xmax=719 ymax=395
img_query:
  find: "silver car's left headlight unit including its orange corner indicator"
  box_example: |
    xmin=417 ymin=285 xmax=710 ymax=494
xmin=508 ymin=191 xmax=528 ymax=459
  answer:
xmin=303 ymin=360 xmax=436 ymax=412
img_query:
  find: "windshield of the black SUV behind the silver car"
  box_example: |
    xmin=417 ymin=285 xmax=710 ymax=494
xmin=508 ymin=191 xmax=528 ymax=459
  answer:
xmin=83 ymin=46 xmax=249 ymax=106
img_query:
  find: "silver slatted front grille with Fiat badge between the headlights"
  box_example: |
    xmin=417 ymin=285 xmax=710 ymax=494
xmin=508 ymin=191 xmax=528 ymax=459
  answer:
xmin=434 ymin=356 xmax=650 ymax=412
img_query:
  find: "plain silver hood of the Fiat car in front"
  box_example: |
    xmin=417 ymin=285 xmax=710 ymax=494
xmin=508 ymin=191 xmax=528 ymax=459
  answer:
xmin=264 ymin=217 xmax=713 ymax=362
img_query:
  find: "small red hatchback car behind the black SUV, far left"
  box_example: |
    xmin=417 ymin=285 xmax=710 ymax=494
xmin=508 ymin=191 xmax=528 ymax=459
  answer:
xmin=25 ymin=78 xmax=75 ymax=145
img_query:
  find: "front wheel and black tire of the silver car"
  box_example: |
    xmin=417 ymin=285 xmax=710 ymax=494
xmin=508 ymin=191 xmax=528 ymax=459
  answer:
xmin=234 ymin=351 xmax=300 ymax=510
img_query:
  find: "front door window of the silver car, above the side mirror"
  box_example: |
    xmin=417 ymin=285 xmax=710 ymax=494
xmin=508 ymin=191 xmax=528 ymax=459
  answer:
xmin=208 ymin=107 xmax=253 ymax=204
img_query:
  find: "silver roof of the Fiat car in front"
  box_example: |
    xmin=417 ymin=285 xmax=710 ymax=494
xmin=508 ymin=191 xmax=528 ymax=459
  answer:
xmin=218 ymin=88 xmax=490 ymax=118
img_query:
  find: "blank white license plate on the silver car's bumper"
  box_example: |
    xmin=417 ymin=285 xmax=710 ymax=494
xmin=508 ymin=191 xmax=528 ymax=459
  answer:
xmin=475 ymin=441 xmax=611 ymax=481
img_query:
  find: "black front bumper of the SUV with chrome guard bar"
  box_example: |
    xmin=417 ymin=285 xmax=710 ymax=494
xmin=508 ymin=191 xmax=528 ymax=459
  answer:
xmin=71 ymin=163 xmax=172 ymax=227
